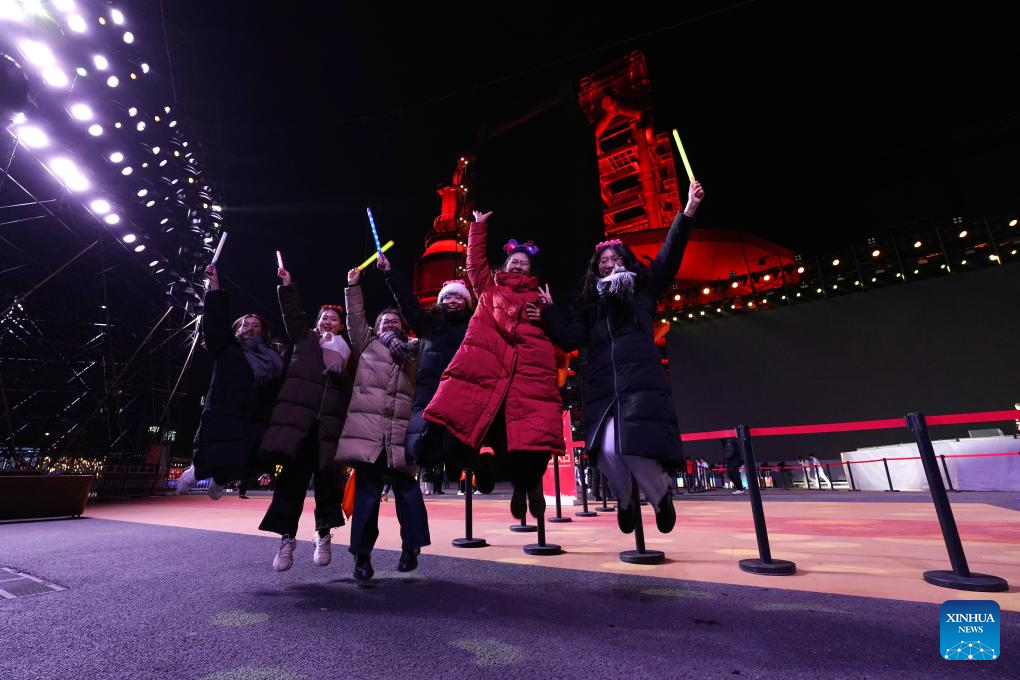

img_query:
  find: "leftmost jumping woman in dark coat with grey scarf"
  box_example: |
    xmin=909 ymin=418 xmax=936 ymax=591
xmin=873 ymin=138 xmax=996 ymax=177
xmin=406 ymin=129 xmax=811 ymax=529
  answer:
xmin=194 ymin=265 xmax=284 ymax=499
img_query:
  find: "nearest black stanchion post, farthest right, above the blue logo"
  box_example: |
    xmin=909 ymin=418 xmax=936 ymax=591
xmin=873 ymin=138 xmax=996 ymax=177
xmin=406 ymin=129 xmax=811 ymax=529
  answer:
xmin=907 ymin=413 xmax=1010 ymax=592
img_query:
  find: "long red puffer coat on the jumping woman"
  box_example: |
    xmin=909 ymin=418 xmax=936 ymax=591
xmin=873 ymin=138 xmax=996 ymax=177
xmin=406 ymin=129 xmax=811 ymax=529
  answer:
xmin=425 ymin=222 xmax=563 ymax=452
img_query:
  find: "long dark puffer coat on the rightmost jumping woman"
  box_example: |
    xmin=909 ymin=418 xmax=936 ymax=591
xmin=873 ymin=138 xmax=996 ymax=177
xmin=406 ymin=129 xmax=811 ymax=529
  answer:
xmin=542 ymin=212 xmax=694 ymax=463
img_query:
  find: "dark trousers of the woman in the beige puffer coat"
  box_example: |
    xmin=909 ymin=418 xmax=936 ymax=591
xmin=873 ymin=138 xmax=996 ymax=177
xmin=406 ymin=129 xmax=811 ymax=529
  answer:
xmin=350 ymin=452 xmax=432 ymax=555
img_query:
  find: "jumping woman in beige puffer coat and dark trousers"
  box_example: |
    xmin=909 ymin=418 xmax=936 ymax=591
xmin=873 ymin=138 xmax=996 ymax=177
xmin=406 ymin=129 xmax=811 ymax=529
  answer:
xmin=337 ymin=268 xmax=431 ymax=581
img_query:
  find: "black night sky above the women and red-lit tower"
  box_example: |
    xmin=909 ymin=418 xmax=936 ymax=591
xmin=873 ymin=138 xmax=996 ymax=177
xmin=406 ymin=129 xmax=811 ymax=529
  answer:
xmin=147 ymin=0 xmax=1020 ymax=320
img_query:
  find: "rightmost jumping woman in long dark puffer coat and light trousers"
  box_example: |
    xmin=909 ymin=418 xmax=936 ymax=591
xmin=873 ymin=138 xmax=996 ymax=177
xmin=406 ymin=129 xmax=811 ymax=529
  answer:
xmin=542 ymin=181 xmax=705 ymax=533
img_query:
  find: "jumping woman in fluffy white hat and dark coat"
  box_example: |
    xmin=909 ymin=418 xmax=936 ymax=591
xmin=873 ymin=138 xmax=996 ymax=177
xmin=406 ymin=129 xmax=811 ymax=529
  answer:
xmin=378 ymin=255 xmax=494 ymax=483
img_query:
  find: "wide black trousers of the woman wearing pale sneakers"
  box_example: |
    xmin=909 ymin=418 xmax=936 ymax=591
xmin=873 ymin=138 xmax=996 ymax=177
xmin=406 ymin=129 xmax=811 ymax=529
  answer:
xmin=258 ymin=427 xmax=344 ymax=538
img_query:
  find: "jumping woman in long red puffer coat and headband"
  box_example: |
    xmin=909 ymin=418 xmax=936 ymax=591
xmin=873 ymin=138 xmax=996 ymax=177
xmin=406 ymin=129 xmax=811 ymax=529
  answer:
xmin=425 ymin=211 xmax=564 ymax=519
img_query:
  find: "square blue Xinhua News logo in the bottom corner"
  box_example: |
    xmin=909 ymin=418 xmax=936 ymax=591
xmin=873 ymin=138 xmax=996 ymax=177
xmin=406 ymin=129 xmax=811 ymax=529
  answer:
xmin=938 ymin=599 xmax=1002 ymax=661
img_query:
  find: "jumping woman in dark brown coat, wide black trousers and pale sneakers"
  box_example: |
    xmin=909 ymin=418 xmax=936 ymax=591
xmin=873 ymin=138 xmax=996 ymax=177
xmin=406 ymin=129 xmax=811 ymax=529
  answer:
xmin=259 ymin=269 xmax=355 ymax=571
